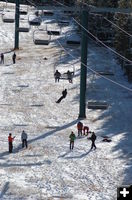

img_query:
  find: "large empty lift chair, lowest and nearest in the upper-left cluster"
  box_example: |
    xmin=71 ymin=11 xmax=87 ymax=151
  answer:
xmin=33 ymin=29 xmax=51 ymax=45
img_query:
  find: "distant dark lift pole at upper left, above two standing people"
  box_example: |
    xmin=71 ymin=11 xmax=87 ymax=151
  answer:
xmin=14 ymin=0 xmax=20 ymax=49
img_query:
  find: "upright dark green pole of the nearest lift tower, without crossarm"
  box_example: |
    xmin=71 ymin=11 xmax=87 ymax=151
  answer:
xmin=79 ymin=10 xmax=88 ymax=118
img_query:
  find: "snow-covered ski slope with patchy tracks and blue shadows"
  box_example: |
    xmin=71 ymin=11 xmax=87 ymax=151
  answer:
xmin=0 ymin=3 xmax=132 ymax=200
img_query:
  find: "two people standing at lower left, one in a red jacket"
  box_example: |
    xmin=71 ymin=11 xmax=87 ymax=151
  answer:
xmin=8 ymin=130 xmax=28 ymax=153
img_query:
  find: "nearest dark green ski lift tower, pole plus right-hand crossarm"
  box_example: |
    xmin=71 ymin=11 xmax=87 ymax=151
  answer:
xmin=79 ymin=6 xmax=132 ymax=118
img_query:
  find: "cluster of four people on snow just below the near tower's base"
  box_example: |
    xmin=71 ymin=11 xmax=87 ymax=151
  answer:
xmin=69 ymin=121 xmax=97 ymax=150
